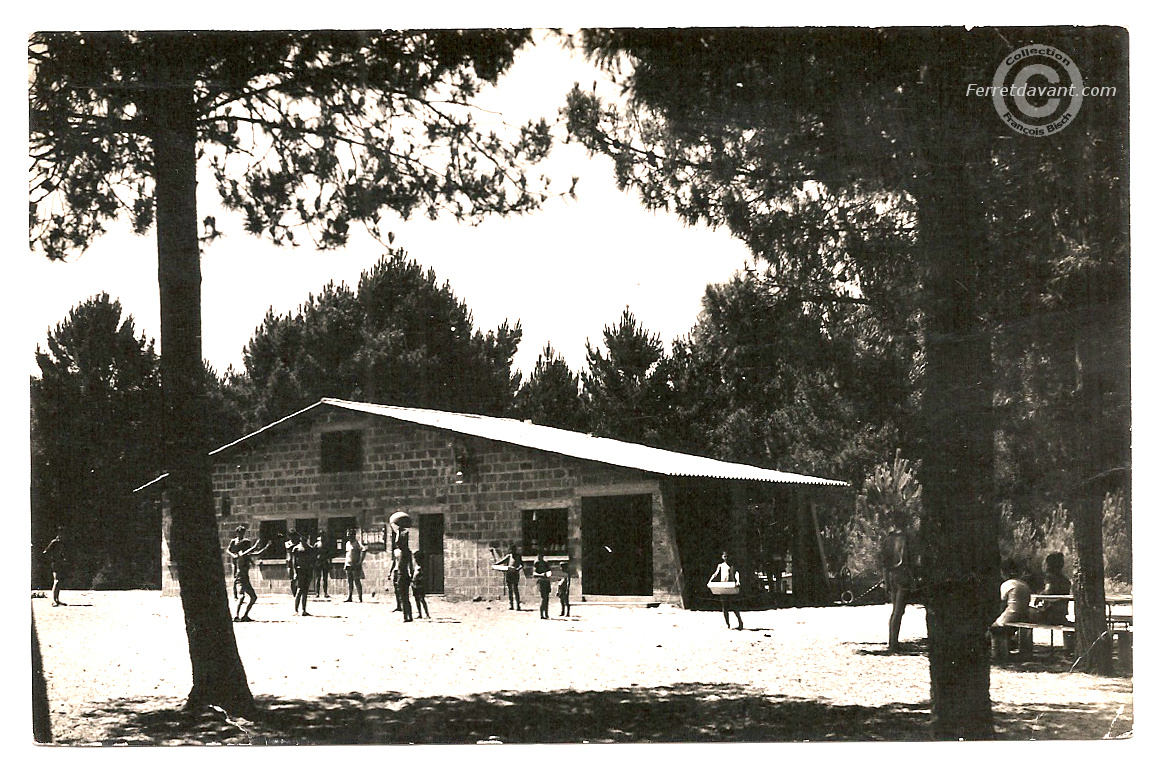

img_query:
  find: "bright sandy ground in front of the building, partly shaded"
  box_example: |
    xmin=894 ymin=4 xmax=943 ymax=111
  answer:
xmin=32 ymin=591 xmax=1134 ymax=744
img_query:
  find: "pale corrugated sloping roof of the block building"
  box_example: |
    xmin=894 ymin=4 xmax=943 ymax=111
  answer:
xmin=211 ymin=398 xmax=848 ymax=486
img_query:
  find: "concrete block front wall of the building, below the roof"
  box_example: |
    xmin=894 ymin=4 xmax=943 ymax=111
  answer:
xmin=163 ymin=410 xmax=680 ymax=603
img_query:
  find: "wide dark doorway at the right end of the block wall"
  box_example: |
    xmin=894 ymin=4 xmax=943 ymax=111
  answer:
xmin=581 ymin=494 xmax=652 ymax=596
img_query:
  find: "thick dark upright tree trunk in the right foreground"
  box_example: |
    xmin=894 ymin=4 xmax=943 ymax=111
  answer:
xmin=916 ymin=53 xmax=1001 ymax=740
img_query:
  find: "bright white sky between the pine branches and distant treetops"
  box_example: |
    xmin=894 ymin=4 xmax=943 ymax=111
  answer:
xmin=16 ymin=36 xmax=749 ymax=376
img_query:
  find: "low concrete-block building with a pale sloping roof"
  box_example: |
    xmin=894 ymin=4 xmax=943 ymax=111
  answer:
xmin=151 ymin=398 xmax=845 ymax=608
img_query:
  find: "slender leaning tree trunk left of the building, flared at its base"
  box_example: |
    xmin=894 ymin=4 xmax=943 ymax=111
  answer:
xmin=148 ymin=62 xmax=254 ymax=714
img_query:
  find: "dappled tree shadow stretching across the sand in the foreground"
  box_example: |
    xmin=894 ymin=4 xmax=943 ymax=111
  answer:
xmin=67 ymin=683 xmax=1133 ymax=744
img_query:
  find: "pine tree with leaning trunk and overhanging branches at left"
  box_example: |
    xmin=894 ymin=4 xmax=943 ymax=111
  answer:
xmin=28 ymin=30 xmax=560 ymax=713
